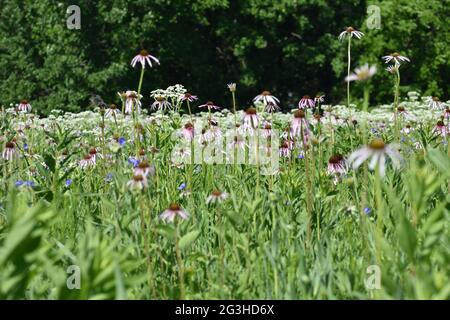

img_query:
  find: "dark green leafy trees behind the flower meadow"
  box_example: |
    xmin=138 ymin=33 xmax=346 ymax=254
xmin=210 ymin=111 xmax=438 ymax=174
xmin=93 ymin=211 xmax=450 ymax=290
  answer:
xmin=0 ymin=0 xmax=450 ymax=114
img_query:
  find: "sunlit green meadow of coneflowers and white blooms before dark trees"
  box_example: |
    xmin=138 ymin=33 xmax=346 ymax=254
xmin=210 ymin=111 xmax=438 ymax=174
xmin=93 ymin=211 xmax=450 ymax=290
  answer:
xmin=0 ymin=8 xmax=450 ymax=299
